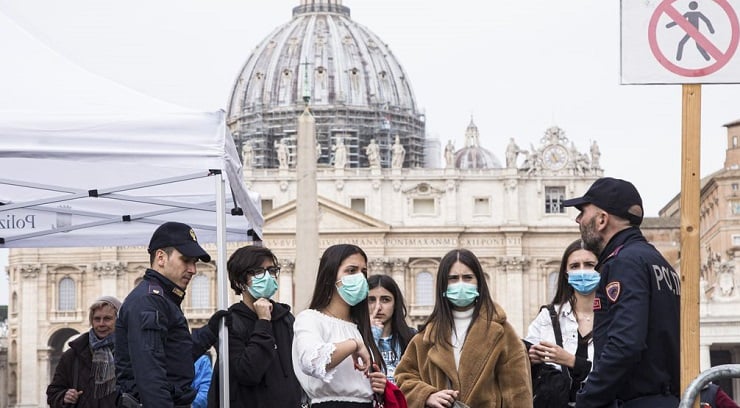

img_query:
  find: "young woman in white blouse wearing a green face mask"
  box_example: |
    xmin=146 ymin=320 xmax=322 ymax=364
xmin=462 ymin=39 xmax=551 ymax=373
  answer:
xmin=293 ymin=244 xmax=386 ymax=408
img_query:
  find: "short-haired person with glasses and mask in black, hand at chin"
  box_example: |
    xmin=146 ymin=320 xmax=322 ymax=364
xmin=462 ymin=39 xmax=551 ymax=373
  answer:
xmin=208 ymin=246 xmax=302 ymax=408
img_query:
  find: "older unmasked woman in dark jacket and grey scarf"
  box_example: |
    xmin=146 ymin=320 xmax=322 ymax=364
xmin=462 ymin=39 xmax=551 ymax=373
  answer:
xmin=46 ymin=296 xmax=121 ymax=408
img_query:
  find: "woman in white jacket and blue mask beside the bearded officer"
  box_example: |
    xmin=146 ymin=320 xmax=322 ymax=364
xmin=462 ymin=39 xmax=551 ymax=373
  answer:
xmin=524 ymin=239 xmax=601 ymax=406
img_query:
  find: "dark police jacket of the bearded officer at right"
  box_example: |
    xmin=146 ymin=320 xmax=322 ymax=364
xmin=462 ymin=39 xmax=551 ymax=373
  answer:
xmin=576 ymin=227 xmax=681 ymax=408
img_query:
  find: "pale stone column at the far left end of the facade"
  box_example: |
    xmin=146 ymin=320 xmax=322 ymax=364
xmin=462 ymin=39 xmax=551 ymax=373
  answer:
xmin=16 ymin=264 xmax=40 ymax=407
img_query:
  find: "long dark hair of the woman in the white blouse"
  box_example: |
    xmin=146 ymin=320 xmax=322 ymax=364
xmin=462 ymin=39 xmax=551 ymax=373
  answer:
xmin=308 ymin=244 xmax=385 ymax=369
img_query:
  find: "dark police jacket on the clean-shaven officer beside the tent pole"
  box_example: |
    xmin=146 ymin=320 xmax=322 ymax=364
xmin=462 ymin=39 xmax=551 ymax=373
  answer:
xmin=115 ymin=269 xmax=218 ymax=408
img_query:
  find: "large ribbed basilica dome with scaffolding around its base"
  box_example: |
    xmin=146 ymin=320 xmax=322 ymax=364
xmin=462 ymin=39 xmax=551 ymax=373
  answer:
xmin=228 ymin=0 xmax=424 ymax=167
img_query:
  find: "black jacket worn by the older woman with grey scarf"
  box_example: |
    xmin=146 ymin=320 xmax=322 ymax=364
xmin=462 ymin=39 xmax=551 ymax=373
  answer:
xmin=46 ymin=332 xmax=118 ymax=408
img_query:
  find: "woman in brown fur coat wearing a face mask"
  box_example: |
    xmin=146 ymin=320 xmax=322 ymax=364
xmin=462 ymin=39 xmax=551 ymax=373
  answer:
xmin=395 ymin=249 xmax=532 ymax=408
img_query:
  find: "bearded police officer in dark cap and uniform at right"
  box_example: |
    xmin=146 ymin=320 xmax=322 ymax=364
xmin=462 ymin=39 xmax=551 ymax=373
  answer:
xmin=563 ymin=177 xmax=681 ymax=408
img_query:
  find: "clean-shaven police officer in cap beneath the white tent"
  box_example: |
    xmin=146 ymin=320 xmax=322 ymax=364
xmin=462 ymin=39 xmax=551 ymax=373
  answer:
xmin=115 ymin=222 xmax=228 ymax=408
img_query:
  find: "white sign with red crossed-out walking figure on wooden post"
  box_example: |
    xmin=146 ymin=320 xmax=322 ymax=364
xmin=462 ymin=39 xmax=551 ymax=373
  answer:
xmin=621 ymin=0 xmax=740 ymax=84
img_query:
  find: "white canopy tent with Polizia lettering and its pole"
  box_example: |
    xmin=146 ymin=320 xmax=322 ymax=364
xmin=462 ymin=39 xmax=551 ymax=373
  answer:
xmin=0 ymin=12 xmax=256 ymax=406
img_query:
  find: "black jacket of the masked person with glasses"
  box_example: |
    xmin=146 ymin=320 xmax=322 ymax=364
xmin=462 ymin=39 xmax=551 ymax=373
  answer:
xmin=208 ymin=300 xmax=302 ymax=408
